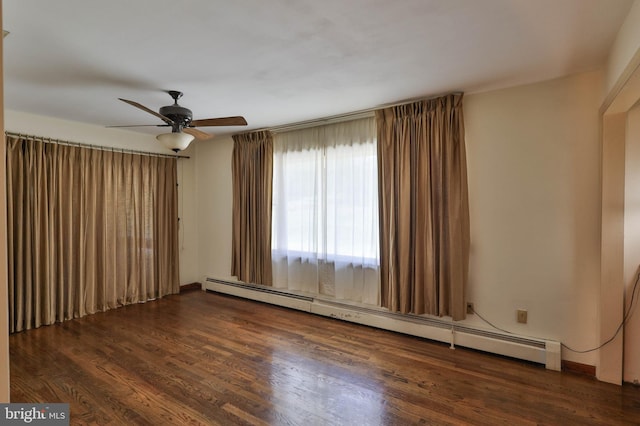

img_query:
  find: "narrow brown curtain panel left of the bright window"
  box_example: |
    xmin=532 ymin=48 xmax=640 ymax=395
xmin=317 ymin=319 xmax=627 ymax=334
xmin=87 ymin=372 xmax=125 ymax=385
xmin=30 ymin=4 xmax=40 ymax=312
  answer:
xmin=231 ymin=131 xmax=273 ymax=285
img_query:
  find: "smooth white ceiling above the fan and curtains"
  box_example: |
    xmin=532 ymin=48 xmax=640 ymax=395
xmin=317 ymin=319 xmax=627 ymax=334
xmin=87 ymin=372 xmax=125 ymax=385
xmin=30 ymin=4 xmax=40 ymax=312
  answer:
xmin=3 ymin=0 xmax=632 ymax=135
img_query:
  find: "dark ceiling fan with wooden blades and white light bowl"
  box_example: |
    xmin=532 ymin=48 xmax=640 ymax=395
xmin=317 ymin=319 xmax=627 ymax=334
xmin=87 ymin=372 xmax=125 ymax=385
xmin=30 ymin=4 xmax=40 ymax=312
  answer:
xmin=109 ymin=90 xmax=247 ymax=152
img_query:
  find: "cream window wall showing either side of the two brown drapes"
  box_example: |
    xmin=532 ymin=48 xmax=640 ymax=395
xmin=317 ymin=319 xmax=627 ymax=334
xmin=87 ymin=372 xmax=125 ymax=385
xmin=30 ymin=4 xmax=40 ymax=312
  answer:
xmin=196 ymin=73 xmax=602 ymax=365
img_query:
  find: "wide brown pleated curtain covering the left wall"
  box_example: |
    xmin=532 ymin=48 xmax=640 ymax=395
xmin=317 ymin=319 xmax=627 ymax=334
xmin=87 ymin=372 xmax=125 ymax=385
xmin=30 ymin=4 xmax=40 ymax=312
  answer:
xmin=7 ymin=137 xmax=180 ymax=332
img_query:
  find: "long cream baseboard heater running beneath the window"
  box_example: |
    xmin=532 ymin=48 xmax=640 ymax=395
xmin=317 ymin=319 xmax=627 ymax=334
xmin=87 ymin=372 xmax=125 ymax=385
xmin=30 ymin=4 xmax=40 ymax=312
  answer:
xmin=203 ymin=277 xmax=561 ymax=371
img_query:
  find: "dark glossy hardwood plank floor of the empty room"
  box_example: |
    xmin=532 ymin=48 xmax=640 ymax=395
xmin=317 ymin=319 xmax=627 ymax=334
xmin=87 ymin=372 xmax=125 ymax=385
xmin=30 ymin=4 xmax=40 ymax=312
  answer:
xmin=9 ymin=291 xmax=640 ymax=425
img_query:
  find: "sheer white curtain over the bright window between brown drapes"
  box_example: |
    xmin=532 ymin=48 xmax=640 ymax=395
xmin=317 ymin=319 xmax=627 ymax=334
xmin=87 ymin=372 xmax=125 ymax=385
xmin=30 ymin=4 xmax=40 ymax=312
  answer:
xmin=271 ymin=118 xmax=380 ymax=305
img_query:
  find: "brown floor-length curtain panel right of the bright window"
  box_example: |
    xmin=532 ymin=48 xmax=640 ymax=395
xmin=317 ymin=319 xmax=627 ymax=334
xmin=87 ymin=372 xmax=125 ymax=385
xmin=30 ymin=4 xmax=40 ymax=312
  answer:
xmin=376 ymin=94 xmax=469 ymax=320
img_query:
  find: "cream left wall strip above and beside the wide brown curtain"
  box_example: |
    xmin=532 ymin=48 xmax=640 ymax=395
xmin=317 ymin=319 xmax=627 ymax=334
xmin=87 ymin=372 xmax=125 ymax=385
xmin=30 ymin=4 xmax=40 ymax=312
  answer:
xmin=4 ymin=111 xmax=200 ymax=285
